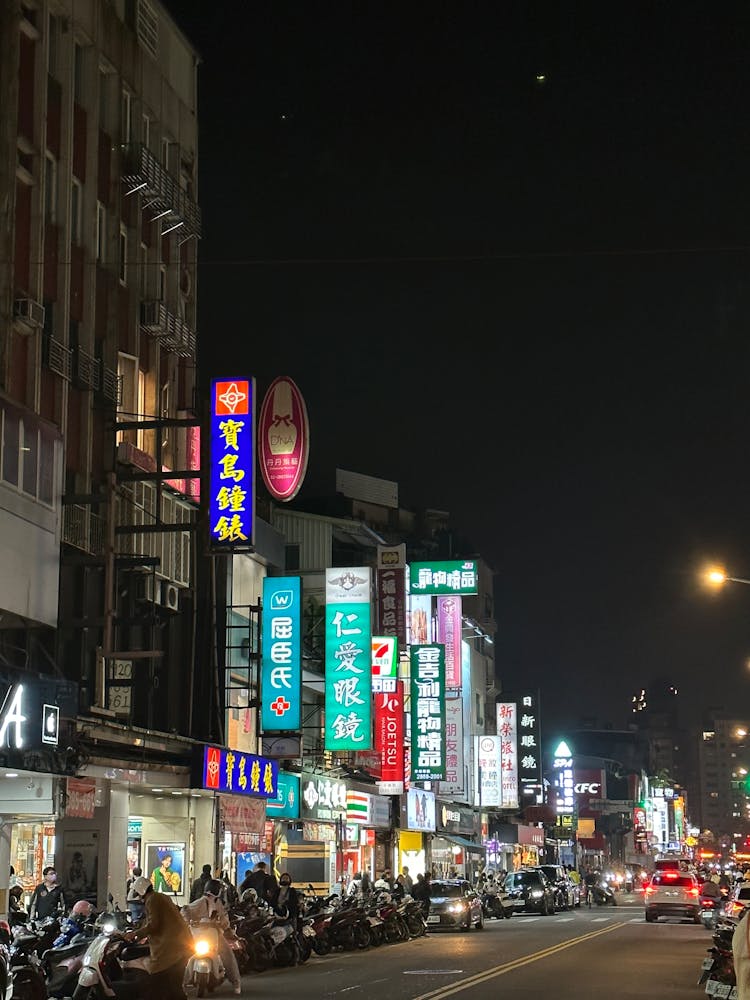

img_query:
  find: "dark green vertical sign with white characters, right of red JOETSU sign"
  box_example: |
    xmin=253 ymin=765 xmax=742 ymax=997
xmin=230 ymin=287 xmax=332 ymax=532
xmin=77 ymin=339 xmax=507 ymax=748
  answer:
xmin=410 ymin=642 xmax=445 ymax=781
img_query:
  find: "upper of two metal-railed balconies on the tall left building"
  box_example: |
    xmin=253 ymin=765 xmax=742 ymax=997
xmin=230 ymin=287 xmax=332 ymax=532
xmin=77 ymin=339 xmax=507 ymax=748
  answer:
xmin=121 ymin=142 xmax=201 ymax=243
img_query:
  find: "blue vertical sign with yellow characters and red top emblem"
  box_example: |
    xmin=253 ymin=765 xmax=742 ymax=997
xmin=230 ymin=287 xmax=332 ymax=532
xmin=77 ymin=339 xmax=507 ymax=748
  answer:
xmin=208 ymin=378 xmax=255 ymax=551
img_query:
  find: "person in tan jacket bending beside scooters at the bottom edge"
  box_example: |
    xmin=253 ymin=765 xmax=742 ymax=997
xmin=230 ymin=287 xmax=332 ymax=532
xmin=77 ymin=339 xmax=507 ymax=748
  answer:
xmin=125 ymin=875 xmax=193 ymax=1000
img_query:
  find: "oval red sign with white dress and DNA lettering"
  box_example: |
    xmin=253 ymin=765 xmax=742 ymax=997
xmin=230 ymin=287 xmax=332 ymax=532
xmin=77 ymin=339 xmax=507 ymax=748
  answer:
xmin=258 ymin=375 xmax=310 ymax=501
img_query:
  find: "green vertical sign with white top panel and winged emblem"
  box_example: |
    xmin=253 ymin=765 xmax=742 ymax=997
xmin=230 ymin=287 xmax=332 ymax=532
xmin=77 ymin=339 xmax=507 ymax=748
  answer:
xmin=325 ymin=567 xmax=372 ymax=750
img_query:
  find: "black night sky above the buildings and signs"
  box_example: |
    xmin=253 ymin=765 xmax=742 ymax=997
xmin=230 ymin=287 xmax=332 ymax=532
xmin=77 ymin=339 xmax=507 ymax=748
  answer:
xmin=166 ymin=0 xmax=750 ymax=726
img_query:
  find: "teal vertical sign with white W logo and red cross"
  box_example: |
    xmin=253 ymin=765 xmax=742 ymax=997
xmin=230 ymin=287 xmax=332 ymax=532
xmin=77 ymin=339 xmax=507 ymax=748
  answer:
xmin=260 ymin=576 xmax=302 ymax=733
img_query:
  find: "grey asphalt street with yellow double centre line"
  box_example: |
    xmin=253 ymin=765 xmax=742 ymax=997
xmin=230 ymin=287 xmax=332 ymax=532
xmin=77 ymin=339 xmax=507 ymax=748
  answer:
xmin=235 ymin=904 xmax=711 ymax=1000
